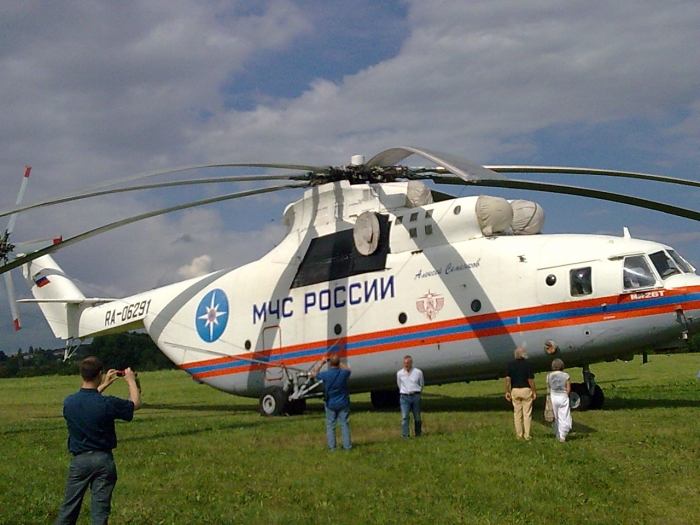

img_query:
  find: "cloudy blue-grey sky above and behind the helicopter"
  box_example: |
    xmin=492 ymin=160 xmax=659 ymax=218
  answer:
xmin=0 ymin=0 xmax=700 ymax=352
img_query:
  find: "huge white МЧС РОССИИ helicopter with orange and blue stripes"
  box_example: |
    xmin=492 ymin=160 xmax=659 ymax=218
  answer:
xmin=0 ymin=147 xmax=700 ymax=416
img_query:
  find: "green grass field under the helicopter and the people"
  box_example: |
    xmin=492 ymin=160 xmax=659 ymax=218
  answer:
xmin=0 ymin=354 xmax=700 ymax=525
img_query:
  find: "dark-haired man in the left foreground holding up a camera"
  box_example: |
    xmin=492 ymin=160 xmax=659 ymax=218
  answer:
xmin=56 ymin=357 xmax=141 ymax=525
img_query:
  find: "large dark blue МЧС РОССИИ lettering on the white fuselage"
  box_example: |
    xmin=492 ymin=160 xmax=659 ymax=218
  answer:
xmin=253 ymin=275 xmax=394 ymax=324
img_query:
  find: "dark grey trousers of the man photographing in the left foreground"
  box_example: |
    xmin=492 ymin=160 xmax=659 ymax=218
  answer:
xmin=56 ymin=450 xmax=117 ymax=525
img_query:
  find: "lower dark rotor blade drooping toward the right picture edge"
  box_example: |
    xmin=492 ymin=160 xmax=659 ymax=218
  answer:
xmin=433 ymin=176 xmax=700 ymax=221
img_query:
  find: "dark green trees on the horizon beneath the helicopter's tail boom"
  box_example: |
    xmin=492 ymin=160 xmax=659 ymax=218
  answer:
xmin=0 ymin=332 xmax=177 ymax=378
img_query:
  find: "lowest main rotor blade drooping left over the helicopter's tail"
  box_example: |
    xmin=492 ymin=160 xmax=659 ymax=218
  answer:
xmin=0 ymin=184 xmax=309 ymax=274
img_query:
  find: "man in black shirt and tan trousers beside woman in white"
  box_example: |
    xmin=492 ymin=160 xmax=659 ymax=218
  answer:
xmin=506 ymin=348 xmax=537 ymax=441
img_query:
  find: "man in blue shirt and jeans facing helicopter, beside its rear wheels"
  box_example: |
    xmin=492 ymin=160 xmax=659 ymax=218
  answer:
xmin=313 ymin=354 xmax=352 ymax=450
